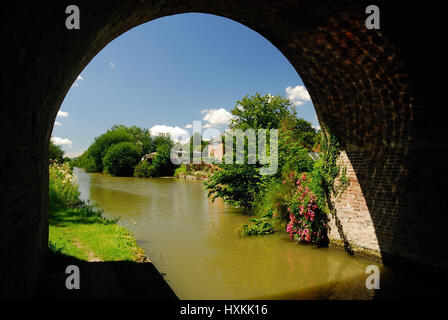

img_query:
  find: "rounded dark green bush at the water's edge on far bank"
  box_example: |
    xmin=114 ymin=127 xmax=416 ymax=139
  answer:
xmin=103 ymin=142 xmax=142 ymax=177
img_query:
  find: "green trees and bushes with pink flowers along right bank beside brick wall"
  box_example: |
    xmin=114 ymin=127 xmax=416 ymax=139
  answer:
xmin=206 ymin=94 xmax=348 ymax=245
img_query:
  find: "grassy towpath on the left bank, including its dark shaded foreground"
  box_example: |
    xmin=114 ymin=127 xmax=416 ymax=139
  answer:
xmin=34 ymin=164 xmax=177 ymax=300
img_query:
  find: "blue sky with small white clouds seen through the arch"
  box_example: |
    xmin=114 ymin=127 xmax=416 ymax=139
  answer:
xmin=52 ymin=13 xmax=318 ymax=157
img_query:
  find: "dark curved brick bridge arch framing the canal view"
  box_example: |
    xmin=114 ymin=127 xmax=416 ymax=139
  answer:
xmin=0 ymin=0 xmax=448 ymax=296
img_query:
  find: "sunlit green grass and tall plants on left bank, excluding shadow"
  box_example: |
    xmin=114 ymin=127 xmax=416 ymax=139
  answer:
xmin=48 ymin=163 xmax=144 ymax=261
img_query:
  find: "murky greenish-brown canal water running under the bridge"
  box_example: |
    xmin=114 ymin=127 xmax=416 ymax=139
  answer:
xmin=75 ymin=168 xmax=396 ymax=299
